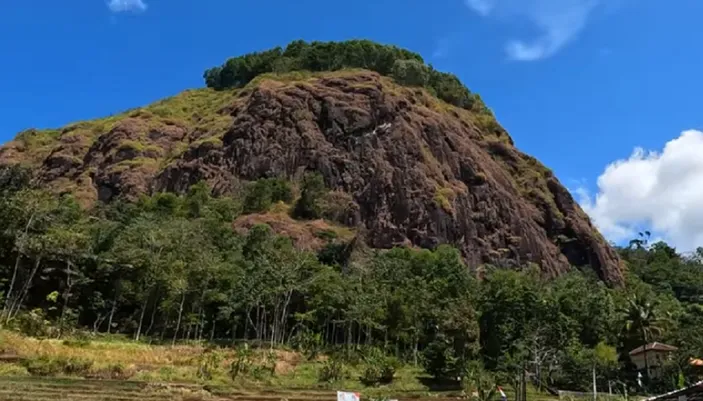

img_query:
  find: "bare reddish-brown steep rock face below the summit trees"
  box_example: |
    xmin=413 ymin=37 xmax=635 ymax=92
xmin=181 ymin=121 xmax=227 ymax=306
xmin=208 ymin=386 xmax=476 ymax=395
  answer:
xmin=0 ymin=72 xmax=622 ymax=283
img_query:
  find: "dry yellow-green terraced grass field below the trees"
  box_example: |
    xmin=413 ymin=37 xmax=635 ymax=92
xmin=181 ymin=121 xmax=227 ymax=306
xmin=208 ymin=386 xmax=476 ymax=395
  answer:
xmin=0 ymin=331 xmax=564 ymax=401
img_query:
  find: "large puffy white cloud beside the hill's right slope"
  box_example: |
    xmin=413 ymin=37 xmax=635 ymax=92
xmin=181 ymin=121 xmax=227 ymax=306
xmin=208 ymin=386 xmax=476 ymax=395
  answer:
xmin=575 ymin=130 xmax=703 ymax=251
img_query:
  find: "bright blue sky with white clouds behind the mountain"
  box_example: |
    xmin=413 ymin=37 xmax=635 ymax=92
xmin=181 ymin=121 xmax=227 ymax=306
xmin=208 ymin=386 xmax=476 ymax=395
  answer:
xmin=0 ymin=0 xmax=703 ymax=248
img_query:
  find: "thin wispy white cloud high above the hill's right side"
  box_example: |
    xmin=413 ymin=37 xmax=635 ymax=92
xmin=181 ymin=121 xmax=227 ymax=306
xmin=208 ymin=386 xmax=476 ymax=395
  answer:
xmin=464 ymin=0 xmax=603 ymax=61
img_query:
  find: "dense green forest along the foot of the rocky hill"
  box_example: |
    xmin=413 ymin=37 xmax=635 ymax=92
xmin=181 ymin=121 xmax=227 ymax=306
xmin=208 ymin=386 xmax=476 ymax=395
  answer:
xmin=0 ymin=168 xmax=703 ymax=392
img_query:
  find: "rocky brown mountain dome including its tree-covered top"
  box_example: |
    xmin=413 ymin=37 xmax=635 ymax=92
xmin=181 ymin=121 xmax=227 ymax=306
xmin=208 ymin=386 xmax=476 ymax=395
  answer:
xmin=0 ymin=41 xmax=622 ymax=284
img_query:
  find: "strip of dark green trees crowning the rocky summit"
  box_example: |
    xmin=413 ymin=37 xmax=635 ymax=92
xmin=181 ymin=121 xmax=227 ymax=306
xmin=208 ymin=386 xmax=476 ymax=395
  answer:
xmin=203 ymin=40 xmax=490 ymax=113
